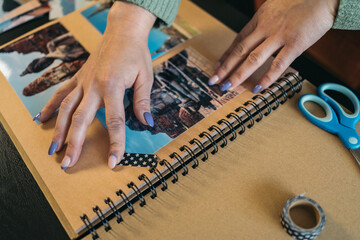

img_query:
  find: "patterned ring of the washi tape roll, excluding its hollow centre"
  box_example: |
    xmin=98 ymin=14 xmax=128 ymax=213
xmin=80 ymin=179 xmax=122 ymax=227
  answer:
xmin=280 ymin=194 xmax=326 ymax=240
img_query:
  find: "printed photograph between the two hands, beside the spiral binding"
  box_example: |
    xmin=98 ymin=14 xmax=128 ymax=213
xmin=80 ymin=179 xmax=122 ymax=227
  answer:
xmin=97 ymin=48 xmax=239 ymax=154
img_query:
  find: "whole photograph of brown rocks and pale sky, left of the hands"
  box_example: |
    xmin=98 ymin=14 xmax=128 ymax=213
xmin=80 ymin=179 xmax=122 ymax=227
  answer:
xmin=0 ymin=23 xmax=89 ymax=116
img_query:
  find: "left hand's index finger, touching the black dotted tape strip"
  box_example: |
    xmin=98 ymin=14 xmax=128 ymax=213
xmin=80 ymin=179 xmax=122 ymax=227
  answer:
xmin=104 ymin=90 xmax=125 ymax=169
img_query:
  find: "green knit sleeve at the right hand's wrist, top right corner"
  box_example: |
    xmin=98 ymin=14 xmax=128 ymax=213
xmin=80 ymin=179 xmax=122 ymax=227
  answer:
xmin=333 ymin=0 xmax=360 ymax=30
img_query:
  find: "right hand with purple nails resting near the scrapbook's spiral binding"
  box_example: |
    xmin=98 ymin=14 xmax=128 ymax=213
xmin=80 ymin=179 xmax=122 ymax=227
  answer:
xmin=209 ymin=0 xmax=339 ymax=93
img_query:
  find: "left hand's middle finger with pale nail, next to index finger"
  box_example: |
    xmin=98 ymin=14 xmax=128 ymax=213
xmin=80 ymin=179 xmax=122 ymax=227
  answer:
xmin=61 ymin=94 xmax=100 ymax=170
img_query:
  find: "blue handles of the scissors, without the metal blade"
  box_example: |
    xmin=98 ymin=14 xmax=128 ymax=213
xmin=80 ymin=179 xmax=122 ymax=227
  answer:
xmin=298 ymin=84 xmax=360 ymax=149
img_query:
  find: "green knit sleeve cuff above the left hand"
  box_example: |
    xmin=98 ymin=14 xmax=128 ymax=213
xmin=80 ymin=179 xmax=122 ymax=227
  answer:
xmin=125 ymin=0 xmax=181 ymax=27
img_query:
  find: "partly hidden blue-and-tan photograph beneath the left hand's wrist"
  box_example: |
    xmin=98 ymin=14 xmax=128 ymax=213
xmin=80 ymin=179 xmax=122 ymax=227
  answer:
xmin=81 ymin=0 xmax=199 ymax=60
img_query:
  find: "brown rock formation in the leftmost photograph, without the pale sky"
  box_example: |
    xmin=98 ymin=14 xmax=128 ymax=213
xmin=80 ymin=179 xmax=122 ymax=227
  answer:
xmin=0 ymin=23 xmax=89 ymax=96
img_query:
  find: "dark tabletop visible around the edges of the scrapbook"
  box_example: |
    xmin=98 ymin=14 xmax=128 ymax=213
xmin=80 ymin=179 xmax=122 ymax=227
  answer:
xmin=0 ymin=0 xmax=348 ymax=240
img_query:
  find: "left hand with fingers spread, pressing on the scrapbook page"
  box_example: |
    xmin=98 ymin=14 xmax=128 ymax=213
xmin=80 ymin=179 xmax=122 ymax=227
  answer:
xmin=38 ymin=2 xmax=156 ymax=169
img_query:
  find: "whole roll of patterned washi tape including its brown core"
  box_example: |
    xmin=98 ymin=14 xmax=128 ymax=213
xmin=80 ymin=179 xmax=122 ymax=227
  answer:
xmin=280 ymin=194 xmax=326 ymax=240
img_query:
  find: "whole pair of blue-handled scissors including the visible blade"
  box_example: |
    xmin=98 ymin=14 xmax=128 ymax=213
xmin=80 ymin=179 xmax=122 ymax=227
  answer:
xmin=298 ymin=83 xmax=360 ymax=166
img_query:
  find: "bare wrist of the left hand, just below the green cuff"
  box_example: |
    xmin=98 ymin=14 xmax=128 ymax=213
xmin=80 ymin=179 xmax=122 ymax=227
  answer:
xmin=105 ymin=1 xmax=156 ymax=37
